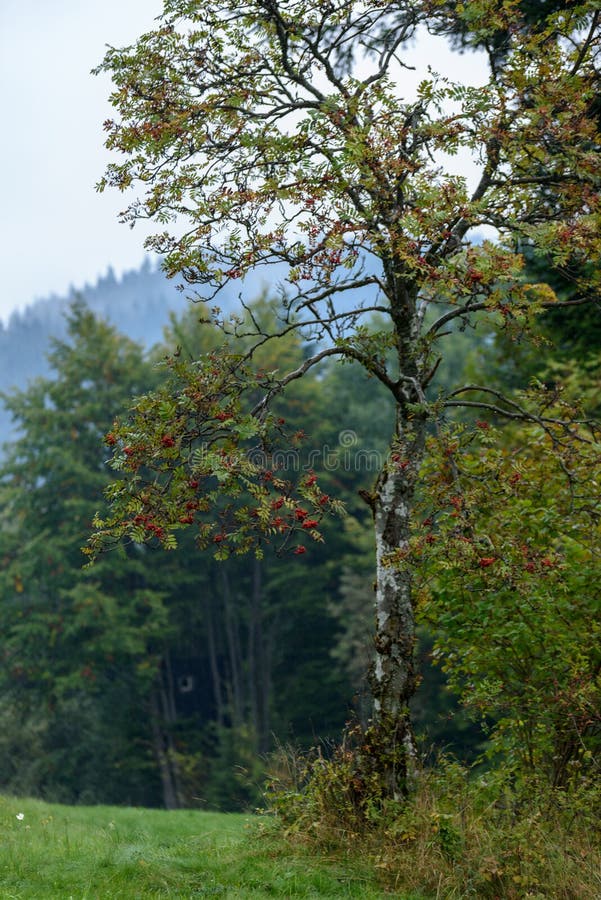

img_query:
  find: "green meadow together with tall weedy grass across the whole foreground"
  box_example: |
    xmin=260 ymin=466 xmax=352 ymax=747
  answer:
xmin=0 ymin=786 xmax=601 ymax=900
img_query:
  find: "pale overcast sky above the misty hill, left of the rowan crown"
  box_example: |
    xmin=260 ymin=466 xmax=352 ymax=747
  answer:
xmin=0 ymin=0 xmax=484 ymax=321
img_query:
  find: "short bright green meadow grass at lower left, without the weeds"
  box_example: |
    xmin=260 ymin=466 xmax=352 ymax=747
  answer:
xmin=0 ymin=797 xmax=399 ymax=900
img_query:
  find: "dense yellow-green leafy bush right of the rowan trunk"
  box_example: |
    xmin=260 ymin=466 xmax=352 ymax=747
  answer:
xmin=413 ymin=414 xmax=601 ymax=787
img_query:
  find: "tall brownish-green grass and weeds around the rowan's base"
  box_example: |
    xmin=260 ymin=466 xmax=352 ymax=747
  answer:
xmin=269 ymin=748 xmax=601 ymax=900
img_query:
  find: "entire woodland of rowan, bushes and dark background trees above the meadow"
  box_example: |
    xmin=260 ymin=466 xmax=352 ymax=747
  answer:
xmin=0 ymin=0 xmax=601 ymax=897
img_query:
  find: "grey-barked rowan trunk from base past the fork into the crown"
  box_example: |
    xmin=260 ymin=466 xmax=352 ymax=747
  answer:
xmin=360 ymin=268 xmax=427 ymax=798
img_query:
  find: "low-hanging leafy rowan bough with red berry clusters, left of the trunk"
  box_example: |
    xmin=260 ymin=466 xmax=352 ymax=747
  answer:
xmin=87 ymin=351 xmax=340 ymax=559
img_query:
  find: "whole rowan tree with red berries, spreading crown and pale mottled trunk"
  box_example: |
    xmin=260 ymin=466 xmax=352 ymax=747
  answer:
xmin=90 ymin=0 xmax=600 ymax=796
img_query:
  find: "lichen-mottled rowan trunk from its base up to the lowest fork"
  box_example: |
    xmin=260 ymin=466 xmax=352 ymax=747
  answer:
xmin=365 ymin=407 xmax=426 ymax=799
